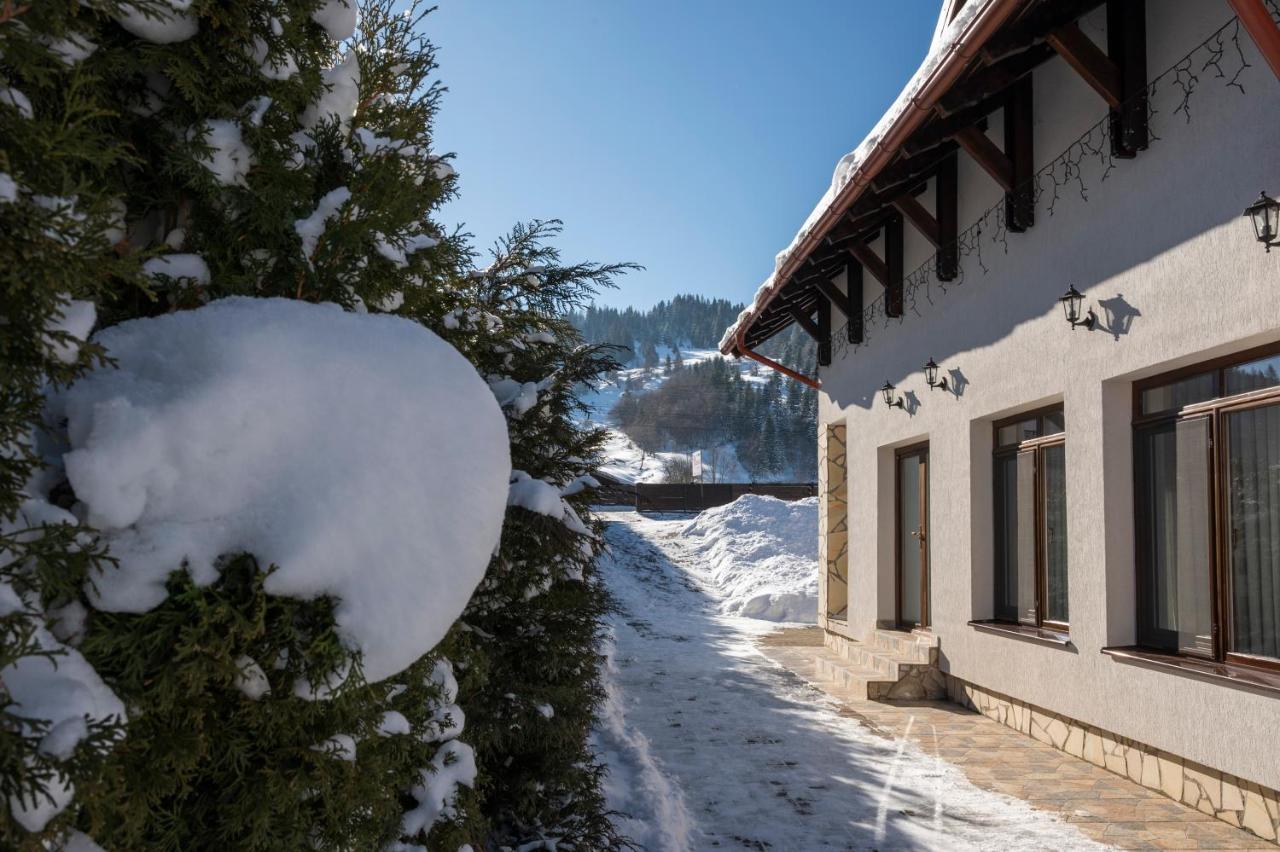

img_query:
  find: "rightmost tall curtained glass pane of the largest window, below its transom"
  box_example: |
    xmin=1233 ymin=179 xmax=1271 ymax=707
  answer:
xmin=1225 ymin=406 xmax=1280 ymax=658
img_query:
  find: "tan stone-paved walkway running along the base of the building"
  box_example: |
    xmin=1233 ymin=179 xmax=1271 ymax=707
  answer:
xmin=760 ymin=628 xmax=1277 ymax=852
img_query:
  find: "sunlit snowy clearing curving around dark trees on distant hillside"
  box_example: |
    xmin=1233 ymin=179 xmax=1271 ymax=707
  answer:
xmin=581 ymin=347 xmax=768 ymax=484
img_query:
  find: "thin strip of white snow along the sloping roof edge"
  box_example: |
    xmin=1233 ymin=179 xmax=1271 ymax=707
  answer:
xmin=719 ymin=0 xmax=992 ymax=351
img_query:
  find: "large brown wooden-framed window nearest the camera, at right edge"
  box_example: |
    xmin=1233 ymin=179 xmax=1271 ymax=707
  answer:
xmin=1133 ymin=344 xmax=1280 ymax=669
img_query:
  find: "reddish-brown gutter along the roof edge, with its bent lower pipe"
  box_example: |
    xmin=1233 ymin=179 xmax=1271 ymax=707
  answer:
xmin=726 ymin=0 xmax=1024 ymax=388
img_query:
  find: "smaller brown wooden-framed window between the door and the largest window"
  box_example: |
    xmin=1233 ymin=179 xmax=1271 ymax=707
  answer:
xmin=992 ymin=406 xmax=1069 ymax=633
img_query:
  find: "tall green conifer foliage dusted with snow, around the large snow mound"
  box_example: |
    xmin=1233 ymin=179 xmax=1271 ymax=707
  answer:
xmin=0 ymin=0 xmax=626 ymax=852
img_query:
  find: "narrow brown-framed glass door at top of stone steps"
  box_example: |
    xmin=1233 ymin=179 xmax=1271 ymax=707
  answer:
xmin=896 ymin=445 xmax=929 ymax=629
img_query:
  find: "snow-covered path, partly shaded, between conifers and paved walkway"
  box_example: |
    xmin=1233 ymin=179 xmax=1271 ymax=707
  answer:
xmin=595 ymin=512 xmax=1101 ymax=852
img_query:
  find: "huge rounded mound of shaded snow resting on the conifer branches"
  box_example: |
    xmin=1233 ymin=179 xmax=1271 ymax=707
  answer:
xmin=51 ymin=298 xmax=511 ymax=681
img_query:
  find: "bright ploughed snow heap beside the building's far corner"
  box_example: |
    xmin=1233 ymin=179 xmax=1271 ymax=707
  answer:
xmin=681 ymin=494 xmax=818 ymax=622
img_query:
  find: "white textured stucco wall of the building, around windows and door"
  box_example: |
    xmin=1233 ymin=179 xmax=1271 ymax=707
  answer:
xmin=819 ymin=0 xmax=1280 ymax=788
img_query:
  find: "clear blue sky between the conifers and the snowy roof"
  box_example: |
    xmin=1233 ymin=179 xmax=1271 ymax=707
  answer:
xmin=428 ymin=0 xmax=941 ymax=307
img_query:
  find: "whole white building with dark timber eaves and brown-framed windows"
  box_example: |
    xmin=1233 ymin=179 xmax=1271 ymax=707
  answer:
xmin=722 ymin=0 xmax=1280 ymax=840
